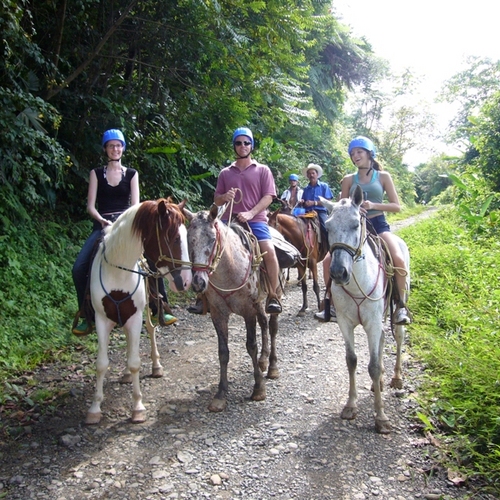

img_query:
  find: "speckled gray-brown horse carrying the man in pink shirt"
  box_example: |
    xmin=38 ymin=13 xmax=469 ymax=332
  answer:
xmin=184 ymin=205 xmax=281 ymax=412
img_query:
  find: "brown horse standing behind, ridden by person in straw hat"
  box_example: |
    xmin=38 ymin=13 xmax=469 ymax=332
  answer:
xmin=268 ymin=208 xmax=328 ymax=316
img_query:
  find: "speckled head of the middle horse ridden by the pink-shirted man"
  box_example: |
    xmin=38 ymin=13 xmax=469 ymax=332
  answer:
xmin=183 ymin=205 xmax=222 ymax=293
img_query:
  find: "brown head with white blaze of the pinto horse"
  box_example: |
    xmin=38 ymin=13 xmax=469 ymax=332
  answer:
xmin=133 ymin=198 xmax=192 ymax=292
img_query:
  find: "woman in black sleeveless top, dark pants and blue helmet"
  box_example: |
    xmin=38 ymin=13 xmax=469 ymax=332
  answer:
xmin=72 ymin=129 xmax=177 ymax=335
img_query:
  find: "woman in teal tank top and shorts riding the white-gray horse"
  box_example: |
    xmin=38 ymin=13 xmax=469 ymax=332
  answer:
xmin=340 ymin=136 xmax=411 ymax=325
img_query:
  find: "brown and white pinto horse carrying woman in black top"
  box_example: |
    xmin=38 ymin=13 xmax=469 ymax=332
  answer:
xmin=86 ymin=198 xmax=191 ymax=424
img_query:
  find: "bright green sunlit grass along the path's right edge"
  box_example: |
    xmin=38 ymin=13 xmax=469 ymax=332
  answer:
xmin=398 ymin=209 xmax=500 ymax=493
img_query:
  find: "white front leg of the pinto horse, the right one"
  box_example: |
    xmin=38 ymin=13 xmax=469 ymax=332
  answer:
xmin=125 ymin=313 xmax=147 ymax=424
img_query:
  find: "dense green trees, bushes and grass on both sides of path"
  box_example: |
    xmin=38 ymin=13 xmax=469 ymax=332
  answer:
xmin=0 ymin=0 xmax=500 ymax=492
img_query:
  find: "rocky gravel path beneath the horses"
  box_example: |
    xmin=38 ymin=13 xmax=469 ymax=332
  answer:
xmin=0 ymin=208 xmax=486 ymax=500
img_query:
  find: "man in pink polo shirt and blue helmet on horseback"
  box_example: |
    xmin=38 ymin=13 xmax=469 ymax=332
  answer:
xmin=214 ymin=127 xmax=281 ymax=314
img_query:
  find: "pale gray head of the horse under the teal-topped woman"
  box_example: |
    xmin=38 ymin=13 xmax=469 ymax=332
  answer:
xmin=320 ymin=185 xmax=365 ymax=285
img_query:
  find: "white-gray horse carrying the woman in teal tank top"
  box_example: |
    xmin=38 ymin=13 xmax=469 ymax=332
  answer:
xmin=321 ymin=186 xmax=410 ymax=434
